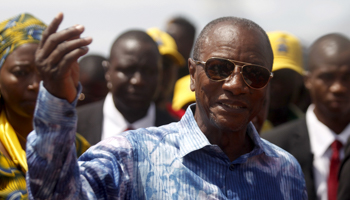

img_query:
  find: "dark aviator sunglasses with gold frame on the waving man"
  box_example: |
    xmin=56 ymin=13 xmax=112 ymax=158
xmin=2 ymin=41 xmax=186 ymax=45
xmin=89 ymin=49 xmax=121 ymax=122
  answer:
xmin=194 ymin=57 xmax=273 ymax=89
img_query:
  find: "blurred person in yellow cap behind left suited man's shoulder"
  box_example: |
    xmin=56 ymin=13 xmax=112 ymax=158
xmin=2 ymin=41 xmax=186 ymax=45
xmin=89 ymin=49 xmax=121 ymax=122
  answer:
xmin=146 ymin=28 xmax=185 ymax=119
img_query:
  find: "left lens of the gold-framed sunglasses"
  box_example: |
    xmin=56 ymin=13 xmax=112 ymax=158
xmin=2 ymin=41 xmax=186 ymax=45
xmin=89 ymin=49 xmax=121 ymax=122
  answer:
xmin=206 ymin=58 xmax=235 ymax=81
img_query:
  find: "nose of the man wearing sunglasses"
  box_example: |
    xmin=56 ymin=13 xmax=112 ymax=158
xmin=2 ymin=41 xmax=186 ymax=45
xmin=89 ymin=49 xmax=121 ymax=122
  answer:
xmin=222 ymin=65 xmax=249 ymax=95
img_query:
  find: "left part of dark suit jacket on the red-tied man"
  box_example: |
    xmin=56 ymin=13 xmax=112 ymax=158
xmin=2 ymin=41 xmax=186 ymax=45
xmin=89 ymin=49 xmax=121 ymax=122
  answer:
xmin=261 ymin=118 xmax=317 ymax=200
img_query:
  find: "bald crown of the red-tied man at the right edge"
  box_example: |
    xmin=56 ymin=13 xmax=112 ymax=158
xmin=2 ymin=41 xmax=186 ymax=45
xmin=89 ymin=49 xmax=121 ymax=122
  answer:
xmin=308 ymin=33 xmax=350 ymax=72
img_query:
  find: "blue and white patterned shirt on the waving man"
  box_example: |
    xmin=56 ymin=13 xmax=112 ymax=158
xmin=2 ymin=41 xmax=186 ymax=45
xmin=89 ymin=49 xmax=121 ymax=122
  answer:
xmin=27 ymin=84 xmax=307 ymax=200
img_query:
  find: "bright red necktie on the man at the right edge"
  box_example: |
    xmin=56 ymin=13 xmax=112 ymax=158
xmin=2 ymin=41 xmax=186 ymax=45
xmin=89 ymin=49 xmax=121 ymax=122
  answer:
xmin=327 ymin=140 xmax=343 ymax=200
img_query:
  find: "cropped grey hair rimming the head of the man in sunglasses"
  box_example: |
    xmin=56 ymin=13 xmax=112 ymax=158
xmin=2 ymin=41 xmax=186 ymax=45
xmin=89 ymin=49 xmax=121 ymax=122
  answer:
xmin=193 ymin=17 xmax=273 ymax=67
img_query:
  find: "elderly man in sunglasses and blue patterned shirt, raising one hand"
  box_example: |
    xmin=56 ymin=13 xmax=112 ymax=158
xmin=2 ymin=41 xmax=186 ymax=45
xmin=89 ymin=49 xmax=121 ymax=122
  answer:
xmin=27 ymin=13 xmax=307 ymax=200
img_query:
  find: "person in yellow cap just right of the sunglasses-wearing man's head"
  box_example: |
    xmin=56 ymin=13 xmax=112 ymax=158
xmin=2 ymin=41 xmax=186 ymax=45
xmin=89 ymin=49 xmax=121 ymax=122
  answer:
xmin=267 ymin=31 xmax=304 ymax=126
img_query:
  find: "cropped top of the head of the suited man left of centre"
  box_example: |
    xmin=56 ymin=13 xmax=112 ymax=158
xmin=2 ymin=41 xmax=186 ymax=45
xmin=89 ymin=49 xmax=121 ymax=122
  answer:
xmin=110 ymin=30 xmax=159 ymax=60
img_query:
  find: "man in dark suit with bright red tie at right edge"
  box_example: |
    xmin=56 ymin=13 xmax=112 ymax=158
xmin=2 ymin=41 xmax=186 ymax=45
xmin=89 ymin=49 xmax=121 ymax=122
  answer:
xmin=262 ymin=34 xmax=350 ymax=200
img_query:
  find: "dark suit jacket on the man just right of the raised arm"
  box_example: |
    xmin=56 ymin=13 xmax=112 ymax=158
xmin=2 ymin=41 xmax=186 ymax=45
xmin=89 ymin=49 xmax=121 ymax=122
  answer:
xmin=77 ymin=100 xmax=178 ymax=145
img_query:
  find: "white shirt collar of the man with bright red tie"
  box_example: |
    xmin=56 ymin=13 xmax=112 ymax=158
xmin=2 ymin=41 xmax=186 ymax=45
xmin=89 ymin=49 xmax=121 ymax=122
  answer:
xmin=306 ymin=104 xmax=350 ymax=157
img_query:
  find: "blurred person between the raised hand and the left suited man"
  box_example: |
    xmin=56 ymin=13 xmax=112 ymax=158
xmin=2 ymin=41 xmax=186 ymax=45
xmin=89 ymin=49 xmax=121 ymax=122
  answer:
xmin=77 ymin=55 xmax=108 ymax=106
